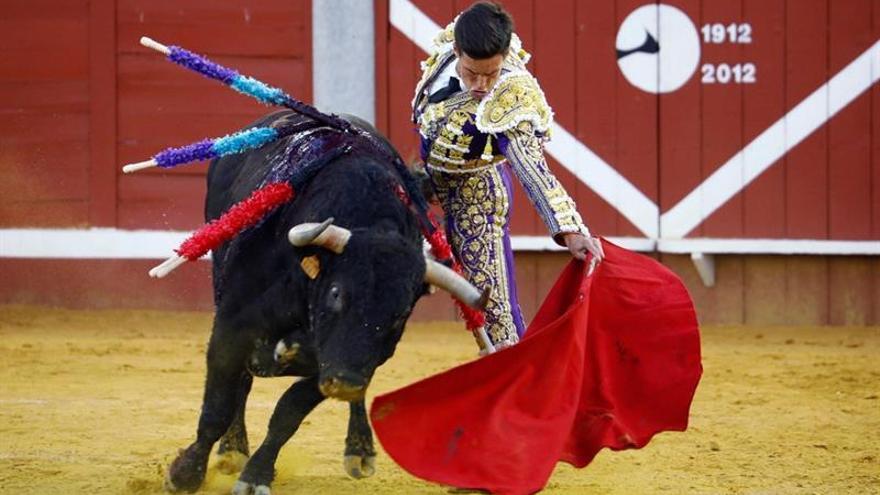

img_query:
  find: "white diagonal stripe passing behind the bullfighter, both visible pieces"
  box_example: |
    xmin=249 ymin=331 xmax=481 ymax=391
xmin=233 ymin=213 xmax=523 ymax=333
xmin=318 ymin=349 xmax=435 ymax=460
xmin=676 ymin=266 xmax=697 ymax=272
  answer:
xmin=389 ymin=0 xmax=660 ymax=238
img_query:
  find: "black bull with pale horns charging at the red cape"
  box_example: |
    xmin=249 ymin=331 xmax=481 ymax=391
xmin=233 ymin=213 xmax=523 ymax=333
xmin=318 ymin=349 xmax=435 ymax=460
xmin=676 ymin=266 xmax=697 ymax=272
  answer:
xmin=166 ymin=112 xmax=485 ymax=494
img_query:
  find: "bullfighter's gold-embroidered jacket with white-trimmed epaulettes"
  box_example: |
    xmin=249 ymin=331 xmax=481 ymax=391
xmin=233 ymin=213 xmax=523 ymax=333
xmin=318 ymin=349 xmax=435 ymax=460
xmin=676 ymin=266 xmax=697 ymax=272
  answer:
xmin=412 ymin=22 xmax=589 ymax=242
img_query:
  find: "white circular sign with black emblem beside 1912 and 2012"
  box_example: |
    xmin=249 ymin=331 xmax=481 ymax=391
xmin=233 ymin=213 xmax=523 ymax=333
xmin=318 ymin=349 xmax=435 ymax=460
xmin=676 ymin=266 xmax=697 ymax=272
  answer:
xmin=616 ymin=3 xmax=700 ymax=93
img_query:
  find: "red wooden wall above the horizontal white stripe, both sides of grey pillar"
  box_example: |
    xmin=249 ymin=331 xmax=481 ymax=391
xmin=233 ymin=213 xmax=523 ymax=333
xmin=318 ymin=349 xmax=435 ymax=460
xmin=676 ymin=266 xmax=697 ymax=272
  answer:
xmin=0 ymin=0 xmax=880 ymax=244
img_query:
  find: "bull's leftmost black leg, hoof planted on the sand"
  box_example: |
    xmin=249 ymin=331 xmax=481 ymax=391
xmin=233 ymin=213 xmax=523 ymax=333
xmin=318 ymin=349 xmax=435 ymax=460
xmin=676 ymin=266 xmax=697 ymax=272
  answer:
xmin=165 ymin=321 xmax=250 ymax=492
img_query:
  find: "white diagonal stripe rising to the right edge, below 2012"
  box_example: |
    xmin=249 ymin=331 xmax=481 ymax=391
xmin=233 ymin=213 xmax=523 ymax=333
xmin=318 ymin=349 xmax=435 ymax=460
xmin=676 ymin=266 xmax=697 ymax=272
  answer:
xmin=660 ymin=41 xmax=880 ymax=238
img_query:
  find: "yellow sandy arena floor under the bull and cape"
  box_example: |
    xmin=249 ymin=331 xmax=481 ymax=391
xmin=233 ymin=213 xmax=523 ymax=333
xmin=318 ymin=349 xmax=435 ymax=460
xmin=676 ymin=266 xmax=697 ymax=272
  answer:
xmin=0 ymin=307 xmax=880 ymax=494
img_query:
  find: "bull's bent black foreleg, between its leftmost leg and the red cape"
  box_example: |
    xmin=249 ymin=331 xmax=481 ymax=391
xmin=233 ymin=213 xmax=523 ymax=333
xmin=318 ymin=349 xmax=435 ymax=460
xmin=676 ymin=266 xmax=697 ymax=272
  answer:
xmin=232 ymin=376 xmax=324 ymax=495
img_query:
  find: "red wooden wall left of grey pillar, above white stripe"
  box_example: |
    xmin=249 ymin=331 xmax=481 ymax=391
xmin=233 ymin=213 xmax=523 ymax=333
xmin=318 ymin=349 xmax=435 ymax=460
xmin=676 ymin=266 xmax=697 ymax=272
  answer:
xmin=0 ymin=0 xmax=312 ymax=230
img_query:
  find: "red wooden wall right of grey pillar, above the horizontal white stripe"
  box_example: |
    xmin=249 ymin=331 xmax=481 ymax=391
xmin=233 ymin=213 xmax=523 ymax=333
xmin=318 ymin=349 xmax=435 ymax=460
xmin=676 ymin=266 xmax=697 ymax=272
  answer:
xmin=377 ymin=0 xmax=880 ymax=240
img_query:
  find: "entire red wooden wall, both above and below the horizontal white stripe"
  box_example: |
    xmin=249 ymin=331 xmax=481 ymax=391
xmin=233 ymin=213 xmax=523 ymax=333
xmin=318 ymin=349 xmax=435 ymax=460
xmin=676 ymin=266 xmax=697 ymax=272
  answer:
xmin=0 ymin=0 xmax=880 ymax=324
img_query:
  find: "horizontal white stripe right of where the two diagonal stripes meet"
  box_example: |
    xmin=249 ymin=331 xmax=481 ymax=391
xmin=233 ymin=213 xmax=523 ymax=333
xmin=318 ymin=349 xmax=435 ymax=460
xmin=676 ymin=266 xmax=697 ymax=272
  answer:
xmin=657 ymin=237 xmax=880 ymax=255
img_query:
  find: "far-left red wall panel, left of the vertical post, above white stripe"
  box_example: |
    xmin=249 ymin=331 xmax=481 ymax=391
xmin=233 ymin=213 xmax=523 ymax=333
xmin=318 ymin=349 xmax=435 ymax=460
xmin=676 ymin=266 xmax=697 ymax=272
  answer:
xmin=0 ymin=1 xmax=89 ymax=227
